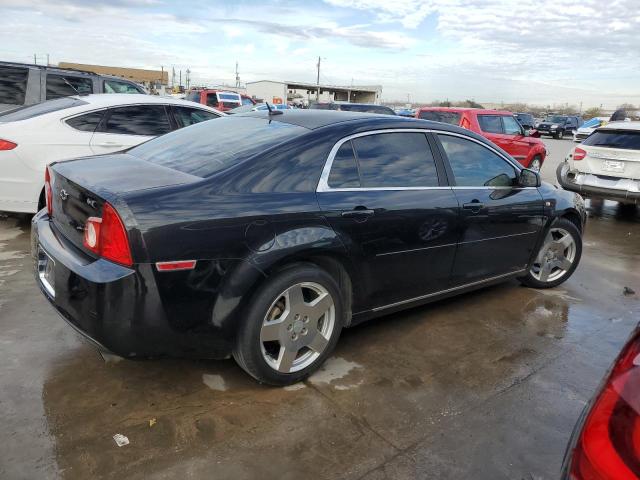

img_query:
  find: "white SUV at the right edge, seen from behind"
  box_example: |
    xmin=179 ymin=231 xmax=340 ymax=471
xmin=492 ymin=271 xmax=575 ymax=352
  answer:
xmin=556 ymin=122 xmax=640 ymax=203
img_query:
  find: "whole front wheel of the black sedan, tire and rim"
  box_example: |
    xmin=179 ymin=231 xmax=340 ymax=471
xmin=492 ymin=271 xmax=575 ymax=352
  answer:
xmin=520 ymin=218 xmax=582 ymax=288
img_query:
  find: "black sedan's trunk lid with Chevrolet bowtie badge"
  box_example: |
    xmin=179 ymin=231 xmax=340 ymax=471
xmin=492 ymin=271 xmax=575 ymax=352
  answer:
xmin=50 ymin=154 xmax=202 ymax=253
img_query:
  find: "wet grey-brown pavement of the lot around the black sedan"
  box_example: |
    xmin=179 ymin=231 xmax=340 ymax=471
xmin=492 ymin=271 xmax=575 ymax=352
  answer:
xmin=0 ymin=139 xmax=640 ymax=480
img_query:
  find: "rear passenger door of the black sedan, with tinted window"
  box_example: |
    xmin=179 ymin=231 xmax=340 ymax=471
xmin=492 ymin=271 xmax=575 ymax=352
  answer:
xmin=317 ymin=130 xmax=458 ymax=308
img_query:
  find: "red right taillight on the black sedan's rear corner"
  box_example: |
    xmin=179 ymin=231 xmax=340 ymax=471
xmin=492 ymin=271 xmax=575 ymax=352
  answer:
xmin=82 ymin=203 xmax=133 ymax=267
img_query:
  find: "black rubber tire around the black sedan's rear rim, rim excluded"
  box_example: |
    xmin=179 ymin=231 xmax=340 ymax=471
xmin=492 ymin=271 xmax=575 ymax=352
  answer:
xmin=233 ymin=264 xmax=346 ymax=386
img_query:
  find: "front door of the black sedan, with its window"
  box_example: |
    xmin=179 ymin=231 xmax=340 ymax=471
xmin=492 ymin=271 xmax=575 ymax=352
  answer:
xmin=437 ymin=133 xmax=544 ymax=286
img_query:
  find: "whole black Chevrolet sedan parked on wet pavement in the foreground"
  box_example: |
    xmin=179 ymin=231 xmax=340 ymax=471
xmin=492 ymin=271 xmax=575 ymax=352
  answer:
xmin=32 ymin=110 xmax=585 ymax=385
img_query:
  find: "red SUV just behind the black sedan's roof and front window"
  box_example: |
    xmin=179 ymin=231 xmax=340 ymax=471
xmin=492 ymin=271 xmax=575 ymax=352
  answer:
xmin=416 ymin=107 xmax=547 ymax=170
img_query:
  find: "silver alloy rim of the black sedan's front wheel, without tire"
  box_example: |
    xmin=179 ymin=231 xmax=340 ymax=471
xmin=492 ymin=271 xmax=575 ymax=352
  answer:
xmin=531 ymin=228 xmax=577 ymax=282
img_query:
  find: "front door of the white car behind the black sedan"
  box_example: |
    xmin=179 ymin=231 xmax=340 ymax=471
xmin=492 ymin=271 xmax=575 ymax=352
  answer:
xmin=91 ymin=105 xmax=171 ymax=155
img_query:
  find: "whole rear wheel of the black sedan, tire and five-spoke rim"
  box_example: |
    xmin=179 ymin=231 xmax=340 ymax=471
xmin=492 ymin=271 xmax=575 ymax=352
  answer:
xmin=233 ymin=265 xmax=345 ymax=385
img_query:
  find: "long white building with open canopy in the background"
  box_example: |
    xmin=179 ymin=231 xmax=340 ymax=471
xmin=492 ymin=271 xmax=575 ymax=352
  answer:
xmin=247 ymin=80 xmax=382 ymax=105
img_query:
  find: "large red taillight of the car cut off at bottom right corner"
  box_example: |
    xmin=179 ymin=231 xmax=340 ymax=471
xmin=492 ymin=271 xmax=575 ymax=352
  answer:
xmin=570 ymin=333 xmax=640 ymax=480
